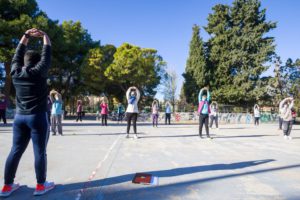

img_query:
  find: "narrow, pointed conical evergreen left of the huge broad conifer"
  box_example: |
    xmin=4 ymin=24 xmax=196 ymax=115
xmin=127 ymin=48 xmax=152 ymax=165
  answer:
xmin=183 ymin=25 xmax=211 ymax=103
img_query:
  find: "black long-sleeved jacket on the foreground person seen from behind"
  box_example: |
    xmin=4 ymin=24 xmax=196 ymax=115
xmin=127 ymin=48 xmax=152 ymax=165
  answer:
xmin=10 ymin=43 xmax=51 ymax=115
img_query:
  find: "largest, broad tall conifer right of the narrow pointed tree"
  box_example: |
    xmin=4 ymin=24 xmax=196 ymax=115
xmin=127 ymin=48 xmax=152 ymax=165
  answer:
xmin=205 ymin=0 xmax=276 ymax=105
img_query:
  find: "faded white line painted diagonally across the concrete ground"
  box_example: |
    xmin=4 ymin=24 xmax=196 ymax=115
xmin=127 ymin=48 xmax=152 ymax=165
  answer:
xmin=75 ymin=135 xmax=122 ymax=200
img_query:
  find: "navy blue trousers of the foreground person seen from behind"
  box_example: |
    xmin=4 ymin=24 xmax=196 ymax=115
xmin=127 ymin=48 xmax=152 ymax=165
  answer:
xmin=4 ymin=112 xmax=49 ymax=184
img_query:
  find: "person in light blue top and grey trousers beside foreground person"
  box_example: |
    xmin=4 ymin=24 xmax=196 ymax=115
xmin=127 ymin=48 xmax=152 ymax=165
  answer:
xmin=50 ymin=90 xmax=63 ymax=135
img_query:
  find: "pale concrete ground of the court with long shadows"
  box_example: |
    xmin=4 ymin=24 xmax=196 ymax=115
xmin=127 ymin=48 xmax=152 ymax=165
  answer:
xmin=0 ymin=121 xmax=300 ymax=200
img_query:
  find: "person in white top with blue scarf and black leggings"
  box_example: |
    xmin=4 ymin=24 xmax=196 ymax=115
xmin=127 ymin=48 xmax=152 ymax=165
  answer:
xmin=126 ymin=87 xmax=141 ymax=139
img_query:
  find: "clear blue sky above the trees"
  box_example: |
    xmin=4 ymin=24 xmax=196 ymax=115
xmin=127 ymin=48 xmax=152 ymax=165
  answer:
xmin=37 ymin=0 xmax=300 ymax=97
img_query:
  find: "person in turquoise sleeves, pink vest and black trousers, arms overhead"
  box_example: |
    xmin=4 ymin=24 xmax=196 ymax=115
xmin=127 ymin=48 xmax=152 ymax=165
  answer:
xmin=198 ymin=87 xmax=212 ymax=139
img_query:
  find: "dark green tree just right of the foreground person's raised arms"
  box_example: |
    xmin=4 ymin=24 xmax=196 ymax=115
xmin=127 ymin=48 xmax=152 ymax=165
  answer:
xmin=50 ymin=21 xmax=99 ymax=100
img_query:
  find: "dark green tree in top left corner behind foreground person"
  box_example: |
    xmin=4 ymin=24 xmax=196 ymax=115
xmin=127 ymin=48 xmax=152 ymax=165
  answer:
xmin=0 ymin=0 xmax=49 ymax=95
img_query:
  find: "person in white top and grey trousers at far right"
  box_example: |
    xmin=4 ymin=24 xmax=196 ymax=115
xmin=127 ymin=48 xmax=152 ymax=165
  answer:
xmin=279 ymin=97 xmax=294 ymax=139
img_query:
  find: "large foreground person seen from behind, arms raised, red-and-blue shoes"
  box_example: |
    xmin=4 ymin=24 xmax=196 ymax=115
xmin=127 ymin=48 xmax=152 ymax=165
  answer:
xmin=0 ymin=28 xmax=54 ymax=197
